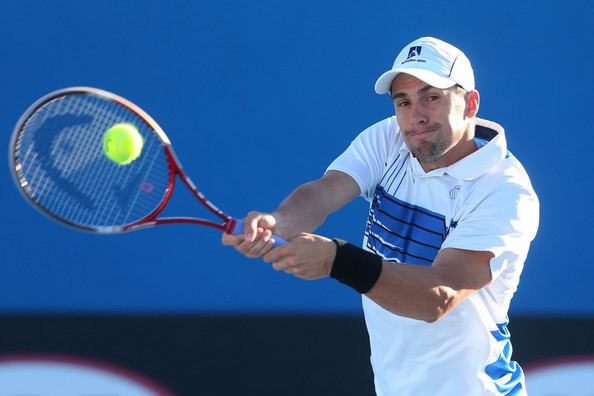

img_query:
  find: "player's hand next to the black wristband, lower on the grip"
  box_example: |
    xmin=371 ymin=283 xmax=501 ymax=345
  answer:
xmin=263 ymin=232 xmax=336 ymax=280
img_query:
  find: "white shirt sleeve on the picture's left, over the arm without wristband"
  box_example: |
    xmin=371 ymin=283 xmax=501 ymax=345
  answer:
xmin=326 ymin=117 xmax=398 ymax=200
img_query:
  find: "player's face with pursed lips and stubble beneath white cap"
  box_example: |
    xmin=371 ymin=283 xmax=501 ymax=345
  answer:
xmin=391 ymin=73 xmax=476 ymax=171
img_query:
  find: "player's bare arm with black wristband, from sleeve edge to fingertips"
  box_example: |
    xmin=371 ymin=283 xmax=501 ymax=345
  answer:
xmin=264 ymin=234 xmax=493 ymax=322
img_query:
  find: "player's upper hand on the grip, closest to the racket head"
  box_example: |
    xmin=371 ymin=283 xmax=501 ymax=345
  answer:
xmin=222 ymin=212 xmax=277 ymax=258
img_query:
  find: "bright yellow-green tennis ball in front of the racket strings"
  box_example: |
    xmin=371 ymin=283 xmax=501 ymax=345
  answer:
xmin=103 ymin=123 xmax=143 ymax=165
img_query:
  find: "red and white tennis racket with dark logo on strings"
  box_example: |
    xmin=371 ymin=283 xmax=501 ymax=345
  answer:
xmin=9 ymin=87 xmax=286 ymax=247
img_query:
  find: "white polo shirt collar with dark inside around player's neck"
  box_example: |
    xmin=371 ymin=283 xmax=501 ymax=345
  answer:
xmin=400 ymin=117 xmax=507 ymax=180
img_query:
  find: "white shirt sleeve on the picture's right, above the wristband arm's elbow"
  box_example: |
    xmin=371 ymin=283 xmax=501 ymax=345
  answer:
xmin=442 ymin=180 xmax=539 ymax=279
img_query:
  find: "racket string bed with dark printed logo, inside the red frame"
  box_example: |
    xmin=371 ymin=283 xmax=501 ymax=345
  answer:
xmin=15 ymin=93 xmax=170 ymax=228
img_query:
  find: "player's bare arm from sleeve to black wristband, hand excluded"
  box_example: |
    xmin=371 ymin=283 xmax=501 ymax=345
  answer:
xmin=330 ymin=241 xmax=494 ymax=322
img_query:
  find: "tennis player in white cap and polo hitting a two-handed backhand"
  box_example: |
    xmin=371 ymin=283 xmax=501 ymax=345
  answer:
xmin=223 ymin=37 xmax=539 ymax=396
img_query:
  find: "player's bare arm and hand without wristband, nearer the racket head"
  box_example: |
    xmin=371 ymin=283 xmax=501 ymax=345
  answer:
xmin=223 ymin=171 xmax=360 ymax=257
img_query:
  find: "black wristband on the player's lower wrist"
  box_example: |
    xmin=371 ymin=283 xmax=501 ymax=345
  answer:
xmin=330 ymin=239 xmax=382 ymax=294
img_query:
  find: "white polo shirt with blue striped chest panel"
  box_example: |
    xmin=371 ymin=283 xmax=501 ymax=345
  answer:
xmin=328 ymin=117 xmax=539 ymax=396
